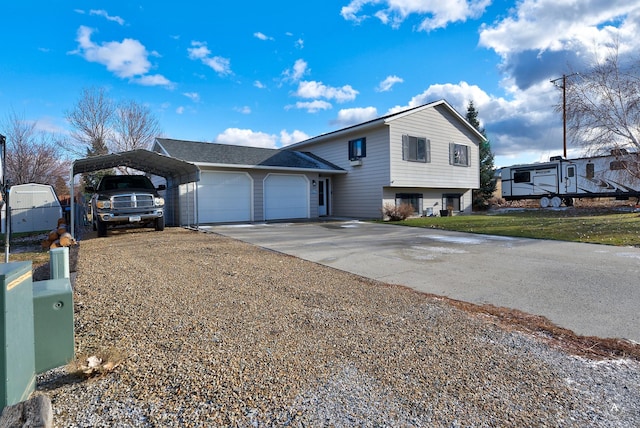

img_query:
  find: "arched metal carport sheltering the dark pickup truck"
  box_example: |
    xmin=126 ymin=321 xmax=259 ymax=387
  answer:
xmin=69 ymin=149 xmax=200 ymax=236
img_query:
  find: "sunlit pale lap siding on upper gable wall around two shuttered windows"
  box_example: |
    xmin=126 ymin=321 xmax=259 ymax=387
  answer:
xmin=390 ymin=106 xmax=480 ymax=189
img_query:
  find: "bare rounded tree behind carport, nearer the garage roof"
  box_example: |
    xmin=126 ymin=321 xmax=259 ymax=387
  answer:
xmin=111 ymin=100 xmax=160 ymax=152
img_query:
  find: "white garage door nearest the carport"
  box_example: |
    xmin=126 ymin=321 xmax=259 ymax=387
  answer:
xmin=198 ymin=171 xmax=252 ymax=223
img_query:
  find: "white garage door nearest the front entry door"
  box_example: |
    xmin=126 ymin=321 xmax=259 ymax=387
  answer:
xmin=264 ymin=174 xmax=309 ymax=220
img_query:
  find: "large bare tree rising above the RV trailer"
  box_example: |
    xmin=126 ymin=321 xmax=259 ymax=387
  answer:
xmin=565 ymin=43 xmax=640 ymax=154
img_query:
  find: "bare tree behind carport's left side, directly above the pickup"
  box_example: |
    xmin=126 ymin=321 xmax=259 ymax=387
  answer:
xmin=66 ymin=88 xmax=115 ymax=156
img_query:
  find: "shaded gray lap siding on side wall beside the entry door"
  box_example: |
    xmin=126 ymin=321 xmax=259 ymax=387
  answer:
xmin=301 ymin=125 xmax=389 ymax=218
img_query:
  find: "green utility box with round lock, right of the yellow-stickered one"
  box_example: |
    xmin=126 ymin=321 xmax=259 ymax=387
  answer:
xmin=33 ymin=278 xmax=75 ymax=373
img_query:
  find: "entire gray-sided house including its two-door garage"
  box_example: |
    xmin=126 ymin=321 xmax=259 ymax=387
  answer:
xmin=153 ymin=100 xmax=484 ymax=224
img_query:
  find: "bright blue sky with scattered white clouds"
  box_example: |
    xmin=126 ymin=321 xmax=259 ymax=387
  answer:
xmin=0 ymin=0 xmax=640 ymax=166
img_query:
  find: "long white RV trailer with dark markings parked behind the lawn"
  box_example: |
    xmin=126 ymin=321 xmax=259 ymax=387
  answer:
xmin=500 ymin=149 xmax=640 ymax=208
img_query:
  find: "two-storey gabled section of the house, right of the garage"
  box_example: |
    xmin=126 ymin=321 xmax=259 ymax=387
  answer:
xmin=287 ymin=100 xmax=484 ymax=218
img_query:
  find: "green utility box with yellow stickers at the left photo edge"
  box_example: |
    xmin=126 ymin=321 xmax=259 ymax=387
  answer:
xmin=0 ymin=262 xmax=36 ymax=409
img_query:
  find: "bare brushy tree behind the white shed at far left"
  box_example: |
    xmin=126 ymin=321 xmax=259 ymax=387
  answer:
xmin=3 ymin=112 xmax=70 ymax=186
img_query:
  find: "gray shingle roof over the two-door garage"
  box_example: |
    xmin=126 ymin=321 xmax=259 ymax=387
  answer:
xmin=156 ymin=138 xmax=343 ymax=171
